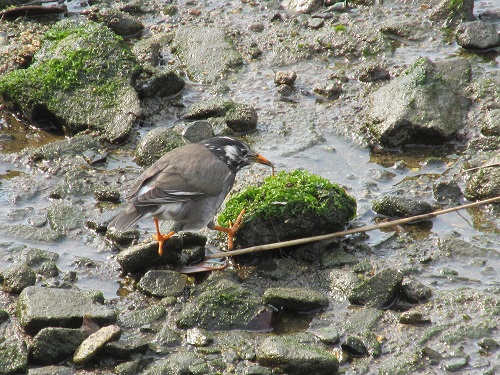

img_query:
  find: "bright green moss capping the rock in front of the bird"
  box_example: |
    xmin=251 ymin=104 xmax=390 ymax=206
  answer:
xmin=218 ymin=170 xmax=356 ymax=225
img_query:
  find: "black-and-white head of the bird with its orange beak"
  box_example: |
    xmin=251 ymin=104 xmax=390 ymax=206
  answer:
xmin=201 ymin=137 xmax=274 ymax=173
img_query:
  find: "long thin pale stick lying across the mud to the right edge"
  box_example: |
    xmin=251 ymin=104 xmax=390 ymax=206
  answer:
xmin=205 ymin=196 xmax=500 ymax=259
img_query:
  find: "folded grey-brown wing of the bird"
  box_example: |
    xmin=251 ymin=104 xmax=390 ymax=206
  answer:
xmin=126 ymin=144 xmax=234 ymax=206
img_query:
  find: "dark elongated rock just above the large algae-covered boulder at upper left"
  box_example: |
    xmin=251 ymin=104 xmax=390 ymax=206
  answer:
xmin=88 ymin=7 xmax=144 ymax=38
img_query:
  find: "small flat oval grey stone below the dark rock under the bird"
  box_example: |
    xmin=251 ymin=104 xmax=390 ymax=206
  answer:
xmin=137 ymin=270 xmax=187 ymax=297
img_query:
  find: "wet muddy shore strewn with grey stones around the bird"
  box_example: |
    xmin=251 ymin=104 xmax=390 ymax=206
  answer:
xmin=0 ymin=0 xmax=500 ymax=375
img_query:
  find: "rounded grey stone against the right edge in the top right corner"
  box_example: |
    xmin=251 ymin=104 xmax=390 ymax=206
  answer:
xmin=457 ymin=21 xmax=500 ymax=50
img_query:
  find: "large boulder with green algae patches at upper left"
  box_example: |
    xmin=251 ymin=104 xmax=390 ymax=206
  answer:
xmin=0 ymin=19 xmax=141 ymax=142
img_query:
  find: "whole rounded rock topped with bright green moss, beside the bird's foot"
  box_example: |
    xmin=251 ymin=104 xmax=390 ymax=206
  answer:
xmin=218 ymin=170 xmax=356 ymax=247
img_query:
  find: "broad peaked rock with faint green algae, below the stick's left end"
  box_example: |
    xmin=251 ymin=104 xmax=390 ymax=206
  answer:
xmin=176 ymin=279 xmax=266 ymax=330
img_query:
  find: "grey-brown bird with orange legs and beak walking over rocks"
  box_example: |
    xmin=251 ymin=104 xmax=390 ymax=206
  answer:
xmin=108 ymin=136 xmax=274 ymax=256
